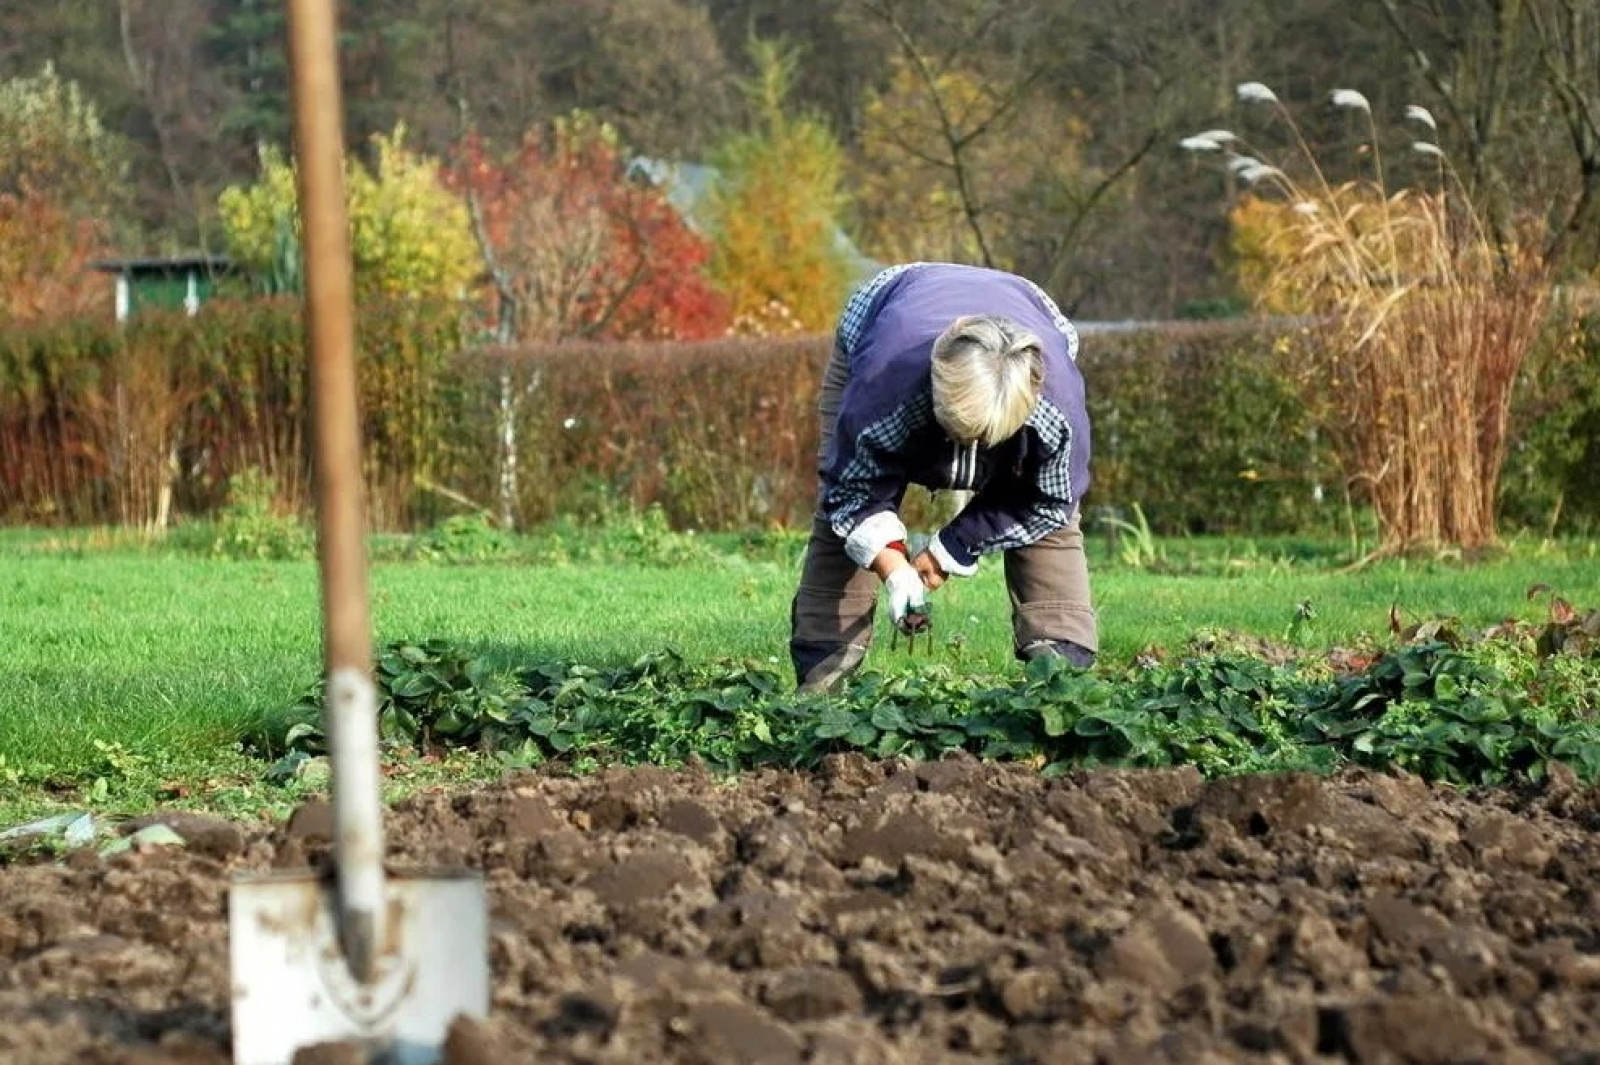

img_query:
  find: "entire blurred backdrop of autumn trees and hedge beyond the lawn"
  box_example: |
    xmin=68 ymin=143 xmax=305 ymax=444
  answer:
xmin=0 ymin=0 xmax=1600 ymax=543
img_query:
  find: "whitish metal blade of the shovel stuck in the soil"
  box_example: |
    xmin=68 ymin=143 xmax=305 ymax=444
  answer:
xmin=227 ymin=870 xmax=490 ymax=1065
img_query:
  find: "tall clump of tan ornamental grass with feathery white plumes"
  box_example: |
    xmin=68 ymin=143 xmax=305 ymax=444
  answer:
xmin=1181 ymin=82 xmax=1550 ymax=553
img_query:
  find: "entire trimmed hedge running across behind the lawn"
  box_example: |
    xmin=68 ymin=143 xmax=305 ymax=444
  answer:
xmin=0 ymin=301 xmax=1600 ymax=534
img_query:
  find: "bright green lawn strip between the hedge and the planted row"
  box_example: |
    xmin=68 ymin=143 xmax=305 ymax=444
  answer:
xmin=0 ymin=531 xmax=1600 ymax=827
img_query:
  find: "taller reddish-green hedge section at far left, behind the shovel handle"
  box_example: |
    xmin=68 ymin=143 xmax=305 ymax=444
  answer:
xmin=0 ymin=299 xmax=464 ymax=528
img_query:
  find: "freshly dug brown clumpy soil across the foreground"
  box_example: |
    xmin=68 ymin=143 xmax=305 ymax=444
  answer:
xmin=0 ymin=756 xmax=1600 ymax=1065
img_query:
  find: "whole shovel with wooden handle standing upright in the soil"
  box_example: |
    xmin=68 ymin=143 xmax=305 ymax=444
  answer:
xmin=229 ymin=0 xmax=490 ymax=1065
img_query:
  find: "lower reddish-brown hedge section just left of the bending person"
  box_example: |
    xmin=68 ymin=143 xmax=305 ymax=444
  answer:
xmin=454 ymin=336 xmax=827 ymax=529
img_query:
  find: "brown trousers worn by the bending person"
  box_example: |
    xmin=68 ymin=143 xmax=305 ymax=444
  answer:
xmin=789 ymin=347 xmax=1099 ymax=688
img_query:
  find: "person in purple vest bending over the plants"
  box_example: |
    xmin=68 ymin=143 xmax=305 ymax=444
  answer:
xmin=789 ymin=262 xmax=1099 ymax=691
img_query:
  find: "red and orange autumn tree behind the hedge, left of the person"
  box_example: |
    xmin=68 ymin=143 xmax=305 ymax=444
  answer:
xmin=446 ymin=118 xmax=728 ymax=341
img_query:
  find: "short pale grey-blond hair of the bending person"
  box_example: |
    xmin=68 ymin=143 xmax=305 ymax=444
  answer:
xmin=933 ymin=315 xmax=1045 ymax=448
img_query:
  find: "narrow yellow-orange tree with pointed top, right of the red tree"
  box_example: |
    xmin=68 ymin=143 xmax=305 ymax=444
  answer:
xmin=707 ymin=40 xmax=854 ymax=331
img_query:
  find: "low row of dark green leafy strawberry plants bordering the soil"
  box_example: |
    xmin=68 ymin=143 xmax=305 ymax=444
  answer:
xmin=283 ymin=591 xmax=1600 ymax=784
